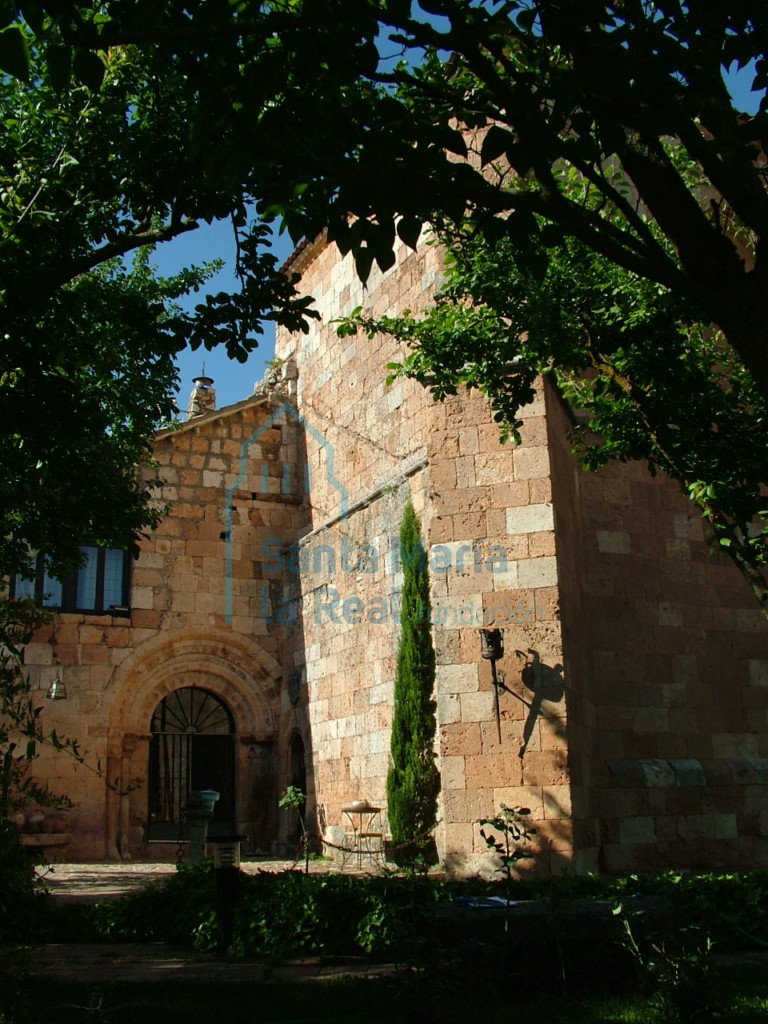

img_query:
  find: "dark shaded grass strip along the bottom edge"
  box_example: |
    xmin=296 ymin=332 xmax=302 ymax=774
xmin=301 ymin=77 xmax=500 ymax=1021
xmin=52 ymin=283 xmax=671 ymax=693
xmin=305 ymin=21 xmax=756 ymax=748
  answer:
xmin=7 ymin=970 xmax=768 ymax=1024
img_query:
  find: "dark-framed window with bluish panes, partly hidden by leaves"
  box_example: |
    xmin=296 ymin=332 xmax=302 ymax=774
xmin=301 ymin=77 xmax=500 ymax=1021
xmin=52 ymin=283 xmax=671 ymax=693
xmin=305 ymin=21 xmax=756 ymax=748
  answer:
xmin=10 ymin=544 xmax=131 ymax=615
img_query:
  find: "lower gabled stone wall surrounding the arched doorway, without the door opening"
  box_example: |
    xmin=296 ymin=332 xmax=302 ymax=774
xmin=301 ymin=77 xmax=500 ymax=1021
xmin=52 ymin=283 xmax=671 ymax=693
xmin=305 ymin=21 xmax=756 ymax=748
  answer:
xmin=20 ymin=396 xmax=303 ymax=859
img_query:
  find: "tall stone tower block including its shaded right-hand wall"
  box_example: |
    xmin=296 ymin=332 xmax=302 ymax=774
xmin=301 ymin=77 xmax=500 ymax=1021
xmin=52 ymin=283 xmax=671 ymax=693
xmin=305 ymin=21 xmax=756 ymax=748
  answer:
xmin=278 ymin=232 xmax=768 ymax=873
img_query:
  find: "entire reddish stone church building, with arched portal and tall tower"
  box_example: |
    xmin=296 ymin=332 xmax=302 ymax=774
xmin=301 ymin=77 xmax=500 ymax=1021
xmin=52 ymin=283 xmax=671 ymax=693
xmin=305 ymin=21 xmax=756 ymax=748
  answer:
xmin=15 ymin=235 xmax=768 ymax=874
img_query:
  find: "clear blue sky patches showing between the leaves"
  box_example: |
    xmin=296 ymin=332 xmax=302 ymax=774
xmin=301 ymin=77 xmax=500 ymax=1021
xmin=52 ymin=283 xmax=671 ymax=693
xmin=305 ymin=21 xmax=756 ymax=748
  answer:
xmin=154 ymin=56 xmax=762 ymax=410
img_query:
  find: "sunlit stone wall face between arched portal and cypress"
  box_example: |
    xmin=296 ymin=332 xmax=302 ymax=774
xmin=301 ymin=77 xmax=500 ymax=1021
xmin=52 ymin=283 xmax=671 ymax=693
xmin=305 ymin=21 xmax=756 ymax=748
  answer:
xmin=276 ymin=235 xmax=438 ymax=842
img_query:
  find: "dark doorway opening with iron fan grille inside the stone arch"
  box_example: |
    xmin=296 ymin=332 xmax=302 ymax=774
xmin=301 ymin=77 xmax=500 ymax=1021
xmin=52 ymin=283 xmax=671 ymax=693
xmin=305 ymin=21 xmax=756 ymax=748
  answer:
xmin=146 ymin=686 xmax=237 ymax=842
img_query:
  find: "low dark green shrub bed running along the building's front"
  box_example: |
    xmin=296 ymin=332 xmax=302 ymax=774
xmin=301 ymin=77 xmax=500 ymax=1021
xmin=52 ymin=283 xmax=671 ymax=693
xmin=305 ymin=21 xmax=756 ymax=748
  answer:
xmin=55 ymin=862 xmax=768 ymax=999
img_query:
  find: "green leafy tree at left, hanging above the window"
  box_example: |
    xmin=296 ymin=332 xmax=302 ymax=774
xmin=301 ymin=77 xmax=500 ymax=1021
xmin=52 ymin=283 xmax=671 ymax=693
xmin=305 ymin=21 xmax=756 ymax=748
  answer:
xmin=0 ymin=30 xmax=317 ymax=574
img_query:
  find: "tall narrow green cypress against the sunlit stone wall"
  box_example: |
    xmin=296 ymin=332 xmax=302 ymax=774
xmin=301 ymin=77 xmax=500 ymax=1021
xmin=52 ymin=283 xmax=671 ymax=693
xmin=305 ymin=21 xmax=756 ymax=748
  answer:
xmin=387 ymin=499 xmax=440 ymax=864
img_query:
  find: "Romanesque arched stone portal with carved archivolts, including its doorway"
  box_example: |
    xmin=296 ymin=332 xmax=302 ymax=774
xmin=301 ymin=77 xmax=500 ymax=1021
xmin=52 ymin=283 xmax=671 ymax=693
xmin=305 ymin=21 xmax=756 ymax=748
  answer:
xmin=106 ymin=630 xmax=281 ymax=858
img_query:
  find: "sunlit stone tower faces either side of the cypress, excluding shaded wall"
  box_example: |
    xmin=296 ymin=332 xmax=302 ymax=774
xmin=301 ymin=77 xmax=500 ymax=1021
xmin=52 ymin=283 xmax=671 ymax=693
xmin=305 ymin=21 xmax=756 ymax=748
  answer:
xmin=276 ymin=237 xmax=572 ymax=872
